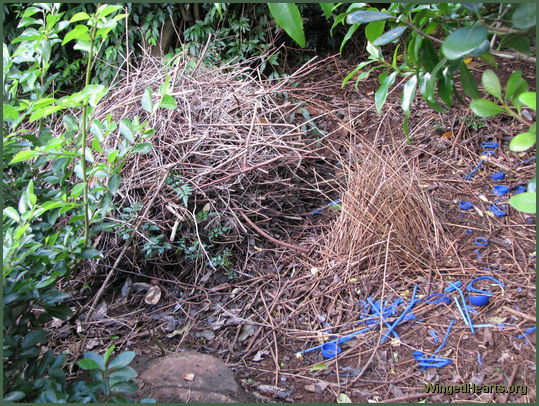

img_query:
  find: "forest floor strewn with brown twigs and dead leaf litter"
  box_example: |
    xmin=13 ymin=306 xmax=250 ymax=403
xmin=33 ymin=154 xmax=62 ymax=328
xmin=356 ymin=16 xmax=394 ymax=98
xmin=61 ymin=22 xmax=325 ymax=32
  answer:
xmin=52 ymin=51 xmax=536 ymax=403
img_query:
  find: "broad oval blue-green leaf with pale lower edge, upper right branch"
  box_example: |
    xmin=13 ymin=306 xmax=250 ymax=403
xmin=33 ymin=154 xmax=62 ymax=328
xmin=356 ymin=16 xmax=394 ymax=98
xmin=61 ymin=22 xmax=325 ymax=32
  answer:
xmin=442 ymin=25 xmax=488 ymax=60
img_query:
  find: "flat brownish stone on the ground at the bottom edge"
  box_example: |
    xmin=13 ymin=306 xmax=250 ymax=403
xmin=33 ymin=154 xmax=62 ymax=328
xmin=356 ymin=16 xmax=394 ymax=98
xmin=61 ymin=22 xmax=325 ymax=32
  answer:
xmin=137 ymin=352 xmax=239 ymax=403
